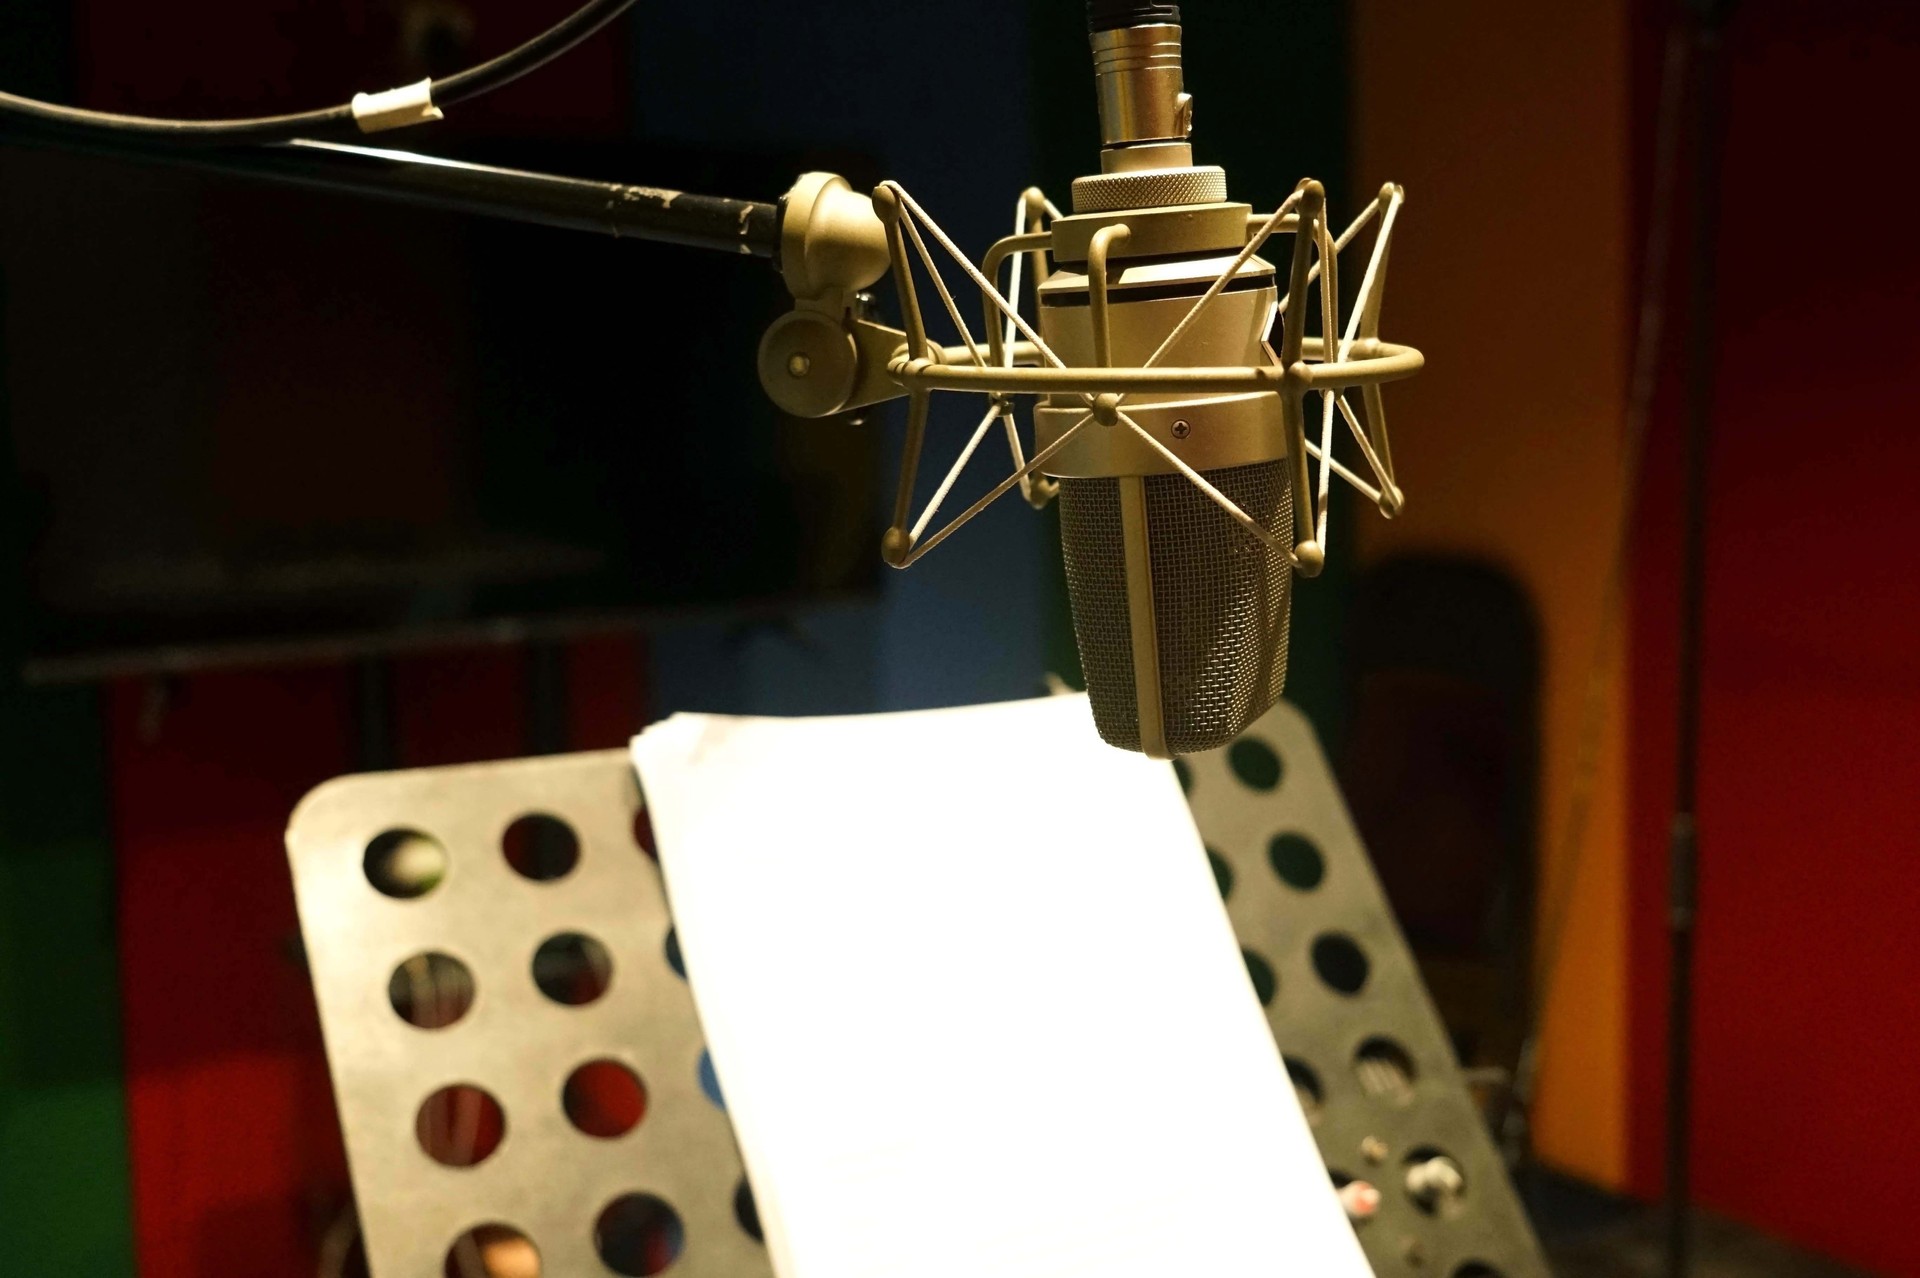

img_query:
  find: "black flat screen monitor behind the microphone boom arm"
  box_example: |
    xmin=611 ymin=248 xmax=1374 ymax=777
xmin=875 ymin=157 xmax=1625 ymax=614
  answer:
xmin=0 ymin=144 xmax=879 ymax=679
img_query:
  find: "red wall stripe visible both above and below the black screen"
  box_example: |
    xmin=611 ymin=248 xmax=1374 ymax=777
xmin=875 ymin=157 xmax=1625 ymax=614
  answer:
xmin=75 ymin=0 xmax=641 ymax=1278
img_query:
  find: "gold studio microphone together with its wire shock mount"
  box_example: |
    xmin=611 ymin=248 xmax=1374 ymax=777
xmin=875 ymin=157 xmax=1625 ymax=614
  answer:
xmin=760 ymin=0 xmax=1423 ymax=758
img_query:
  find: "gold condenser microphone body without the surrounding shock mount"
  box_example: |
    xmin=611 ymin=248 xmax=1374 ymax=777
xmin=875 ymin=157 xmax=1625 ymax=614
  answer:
xmin=1035 ymin=0 xmax=1296 ymax=758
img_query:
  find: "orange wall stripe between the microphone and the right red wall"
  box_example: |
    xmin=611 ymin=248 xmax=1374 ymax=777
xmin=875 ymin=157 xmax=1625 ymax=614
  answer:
xmin=1332 ymin=0 xmax=1632 ymax=1186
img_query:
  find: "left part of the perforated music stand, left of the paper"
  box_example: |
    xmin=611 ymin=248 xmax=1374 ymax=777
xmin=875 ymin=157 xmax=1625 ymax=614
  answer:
xmin=286 ymin=750 xmax=772 ymax=1278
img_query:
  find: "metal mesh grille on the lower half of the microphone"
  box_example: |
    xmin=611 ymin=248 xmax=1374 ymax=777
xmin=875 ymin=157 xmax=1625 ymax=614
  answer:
xmin=1060 ymin=461 xmax=1294 ymax=754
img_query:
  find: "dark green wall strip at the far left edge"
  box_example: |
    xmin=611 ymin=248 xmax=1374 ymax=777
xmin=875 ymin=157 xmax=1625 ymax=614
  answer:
xmin=0 ymin=0 xmax=134 ymax=1243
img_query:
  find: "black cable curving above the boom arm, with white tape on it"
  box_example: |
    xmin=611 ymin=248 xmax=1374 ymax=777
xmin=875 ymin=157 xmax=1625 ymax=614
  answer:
xmin=0 ymin=0 xmax=634 ymax=146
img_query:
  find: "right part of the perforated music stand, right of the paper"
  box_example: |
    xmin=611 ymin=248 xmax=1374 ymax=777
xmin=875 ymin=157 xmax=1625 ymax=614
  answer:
xmin=1179 ymin=702 xmax=1549 ymax=1278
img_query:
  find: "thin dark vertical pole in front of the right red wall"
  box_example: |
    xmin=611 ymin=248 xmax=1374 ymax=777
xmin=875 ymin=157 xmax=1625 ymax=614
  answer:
xmin=1667 ymin=0 xmax=1726 ymax=1278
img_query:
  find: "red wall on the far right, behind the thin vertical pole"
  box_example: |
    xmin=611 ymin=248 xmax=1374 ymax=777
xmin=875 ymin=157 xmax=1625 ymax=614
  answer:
xmin=1630 ymin=0 xmax=1920 ymax=1272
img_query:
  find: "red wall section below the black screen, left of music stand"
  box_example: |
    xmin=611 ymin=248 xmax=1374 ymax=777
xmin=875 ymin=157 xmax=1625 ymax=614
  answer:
xmin=109 ymin=639 xmax=643 ymax=1278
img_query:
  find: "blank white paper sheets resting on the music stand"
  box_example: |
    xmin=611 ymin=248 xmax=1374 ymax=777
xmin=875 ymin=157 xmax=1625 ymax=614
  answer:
xmin=634 ymin=697 xmax=1369 ymax=1278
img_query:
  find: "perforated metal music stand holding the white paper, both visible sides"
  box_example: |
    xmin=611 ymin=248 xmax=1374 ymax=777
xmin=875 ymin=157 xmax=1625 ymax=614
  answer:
xmin=288 ymin=704 xmax=1548 ymax=1278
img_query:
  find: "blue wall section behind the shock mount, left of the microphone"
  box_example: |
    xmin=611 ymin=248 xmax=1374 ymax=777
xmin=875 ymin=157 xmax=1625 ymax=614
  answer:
xmin=634 ymin=0 xmax=1052 ymax=714
